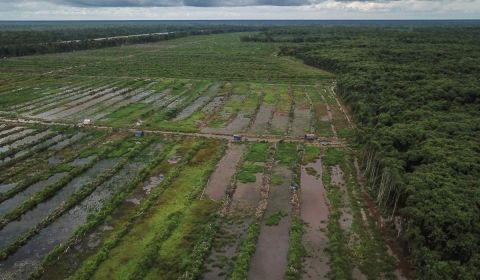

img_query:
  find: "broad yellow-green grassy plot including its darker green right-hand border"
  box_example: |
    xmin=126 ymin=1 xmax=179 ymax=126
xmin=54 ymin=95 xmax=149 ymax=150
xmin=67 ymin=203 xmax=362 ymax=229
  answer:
xmin=72 ymin=141 xmax=223 ymax=279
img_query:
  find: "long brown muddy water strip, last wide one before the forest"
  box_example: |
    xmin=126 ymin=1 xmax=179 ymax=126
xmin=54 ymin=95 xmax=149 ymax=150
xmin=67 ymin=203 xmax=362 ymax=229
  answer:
xmin=300 ymin=159 xmax=330 ymax=279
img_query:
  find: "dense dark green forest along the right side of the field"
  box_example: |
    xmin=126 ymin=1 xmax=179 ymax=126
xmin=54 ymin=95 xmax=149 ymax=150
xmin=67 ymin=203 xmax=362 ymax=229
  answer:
xmin=242 ymin=26 xmax=480 ymax=279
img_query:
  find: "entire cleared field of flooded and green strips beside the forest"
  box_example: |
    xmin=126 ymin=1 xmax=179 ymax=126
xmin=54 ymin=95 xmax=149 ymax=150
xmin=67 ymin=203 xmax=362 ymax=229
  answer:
xmin=0 ymin=31 xmax=401 ymax=280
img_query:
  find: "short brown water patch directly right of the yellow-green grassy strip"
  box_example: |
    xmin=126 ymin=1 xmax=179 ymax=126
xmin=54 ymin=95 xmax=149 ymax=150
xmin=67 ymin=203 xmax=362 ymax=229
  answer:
xmin=204 ymin=143 xmax=245 ymax=200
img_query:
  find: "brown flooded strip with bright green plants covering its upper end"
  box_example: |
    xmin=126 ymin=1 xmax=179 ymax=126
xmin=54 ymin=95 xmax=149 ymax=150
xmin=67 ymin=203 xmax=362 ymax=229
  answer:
xmin=203 ymin=143 xmax=272 ymax=279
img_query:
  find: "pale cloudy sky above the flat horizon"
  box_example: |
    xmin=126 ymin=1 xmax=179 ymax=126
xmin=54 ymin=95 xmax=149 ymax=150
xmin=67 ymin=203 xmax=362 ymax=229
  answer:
xmin=0 ymin=0 xmax=480 ymax=20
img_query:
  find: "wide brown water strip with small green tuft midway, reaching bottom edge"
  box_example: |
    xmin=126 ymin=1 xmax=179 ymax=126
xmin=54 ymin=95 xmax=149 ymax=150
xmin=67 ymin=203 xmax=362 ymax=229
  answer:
xmin=248 ymin=166 xmax=292 ymax=280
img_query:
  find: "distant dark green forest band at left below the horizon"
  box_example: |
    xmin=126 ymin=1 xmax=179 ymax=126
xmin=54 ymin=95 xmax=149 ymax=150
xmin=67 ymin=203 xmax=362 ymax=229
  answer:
xmin=0 ymin=23 xmax=259 ymax=57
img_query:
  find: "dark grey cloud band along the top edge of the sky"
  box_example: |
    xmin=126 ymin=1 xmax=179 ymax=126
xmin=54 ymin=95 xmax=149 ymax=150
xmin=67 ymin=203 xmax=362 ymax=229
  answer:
xmin=50 ymin=0 xmax=396 ymax=7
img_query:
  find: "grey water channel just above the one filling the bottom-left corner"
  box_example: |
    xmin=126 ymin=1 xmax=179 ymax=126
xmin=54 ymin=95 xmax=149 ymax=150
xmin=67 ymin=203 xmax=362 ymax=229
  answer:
xmin=0 ymin=159 xmax=118 ymax=252
